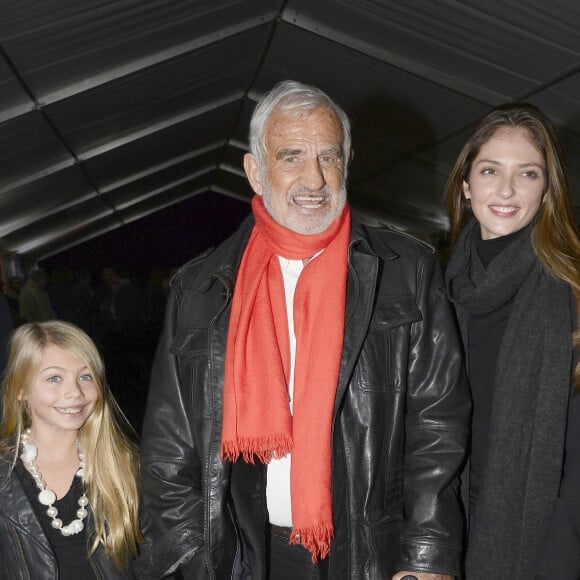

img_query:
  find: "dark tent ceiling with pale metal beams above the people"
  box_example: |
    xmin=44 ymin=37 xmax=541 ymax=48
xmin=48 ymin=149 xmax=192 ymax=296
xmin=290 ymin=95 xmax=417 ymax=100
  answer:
xmin=0 ymin=0 xmax=580 ymax=259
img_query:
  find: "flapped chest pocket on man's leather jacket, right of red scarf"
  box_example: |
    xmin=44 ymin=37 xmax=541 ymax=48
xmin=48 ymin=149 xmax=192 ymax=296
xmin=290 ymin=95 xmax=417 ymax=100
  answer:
xmin=357 ymin=296 xmax=423 ymax=393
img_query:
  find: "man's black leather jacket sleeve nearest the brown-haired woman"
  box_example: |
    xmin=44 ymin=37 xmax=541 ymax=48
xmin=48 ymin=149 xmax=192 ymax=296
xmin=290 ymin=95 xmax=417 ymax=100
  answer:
xmin=398 ymin=256 xmax=471 ymax=576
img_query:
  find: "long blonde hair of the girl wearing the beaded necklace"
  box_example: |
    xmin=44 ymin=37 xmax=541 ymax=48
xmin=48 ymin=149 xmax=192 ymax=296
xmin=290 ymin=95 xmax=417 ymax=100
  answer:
xmin=0 ymin=320 xmax=143 ymax=569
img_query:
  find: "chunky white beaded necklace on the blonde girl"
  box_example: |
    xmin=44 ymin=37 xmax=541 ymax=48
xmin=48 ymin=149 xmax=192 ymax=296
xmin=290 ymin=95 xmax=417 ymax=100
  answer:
xmin=20 ymin=429 xmax=89 ymax=536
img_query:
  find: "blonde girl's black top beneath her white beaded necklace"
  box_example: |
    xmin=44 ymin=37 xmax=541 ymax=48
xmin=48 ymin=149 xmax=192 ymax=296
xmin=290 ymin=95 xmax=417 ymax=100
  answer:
xmin=15 ymin=461 xmax=97 ymax=580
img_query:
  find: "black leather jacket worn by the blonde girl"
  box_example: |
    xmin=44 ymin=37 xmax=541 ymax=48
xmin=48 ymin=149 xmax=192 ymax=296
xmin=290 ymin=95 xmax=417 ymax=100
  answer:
xmin=0 ymin=457 xmax=135 ymax=580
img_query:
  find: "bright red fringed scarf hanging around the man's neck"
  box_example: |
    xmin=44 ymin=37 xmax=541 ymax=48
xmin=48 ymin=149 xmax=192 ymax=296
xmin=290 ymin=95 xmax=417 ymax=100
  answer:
xmin=221 ymin=196 xmax=350 ymax=562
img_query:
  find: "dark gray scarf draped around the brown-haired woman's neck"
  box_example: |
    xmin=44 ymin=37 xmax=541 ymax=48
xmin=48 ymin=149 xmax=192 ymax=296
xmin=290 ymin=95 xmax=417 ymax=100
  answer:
xmin=446 ymin=221 xmax=575 ymax=580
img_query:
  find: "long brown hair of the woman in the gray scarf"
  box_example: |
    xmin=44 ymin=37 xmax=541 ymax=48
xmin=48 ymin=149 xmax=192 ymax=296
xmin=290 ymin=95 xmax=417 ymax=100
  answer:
xmin=445 ymin=103 xmax=580 ymax=390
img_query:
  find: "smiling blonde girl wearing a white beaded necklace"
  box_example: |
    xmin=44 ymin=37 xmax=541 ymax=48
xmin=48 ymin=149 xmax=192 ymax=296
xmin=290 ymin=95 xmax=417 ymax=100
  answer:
xmin=0 ymin=321 xmax=141 ymax=580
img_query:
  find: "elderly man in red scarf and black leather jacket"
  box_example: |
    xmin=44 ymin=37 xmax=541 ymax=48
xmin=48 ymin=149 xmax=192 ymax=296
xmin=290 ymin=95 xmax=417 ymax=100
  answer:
xmin=137 ymin=81 xmax=469 ymax=580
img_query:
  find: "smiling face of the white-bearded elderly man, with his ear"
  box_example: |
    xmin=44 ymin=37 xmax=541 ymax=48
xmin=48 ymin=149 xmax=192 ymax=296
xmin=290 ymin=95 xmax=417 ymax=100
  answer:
xmin=244 ymin=109 xmax=346 ymax=234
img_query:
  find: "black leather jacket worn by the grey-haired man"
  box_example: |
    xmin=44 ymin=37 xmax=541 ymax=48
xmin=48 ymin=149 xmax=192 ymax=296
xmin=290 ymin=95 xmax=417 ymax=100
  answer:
xmin=137 ymin=217 xmax=470 ymax=580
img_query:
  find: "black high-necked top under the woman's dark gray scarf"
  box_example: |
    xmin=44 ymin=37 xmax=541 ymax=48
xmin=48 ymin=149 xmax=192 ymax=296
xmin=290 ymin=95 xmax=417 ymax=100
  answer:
xmin=467 ymin=230 xmax=522 ymax=513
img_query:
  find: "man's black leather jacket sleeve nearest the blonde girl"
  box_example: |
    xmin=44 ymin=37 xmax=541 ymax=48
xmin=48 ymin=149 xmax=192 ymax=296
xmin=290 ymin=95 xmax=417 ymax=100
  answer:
xmin=135 ymin=289 xmax=205 ymax=580
